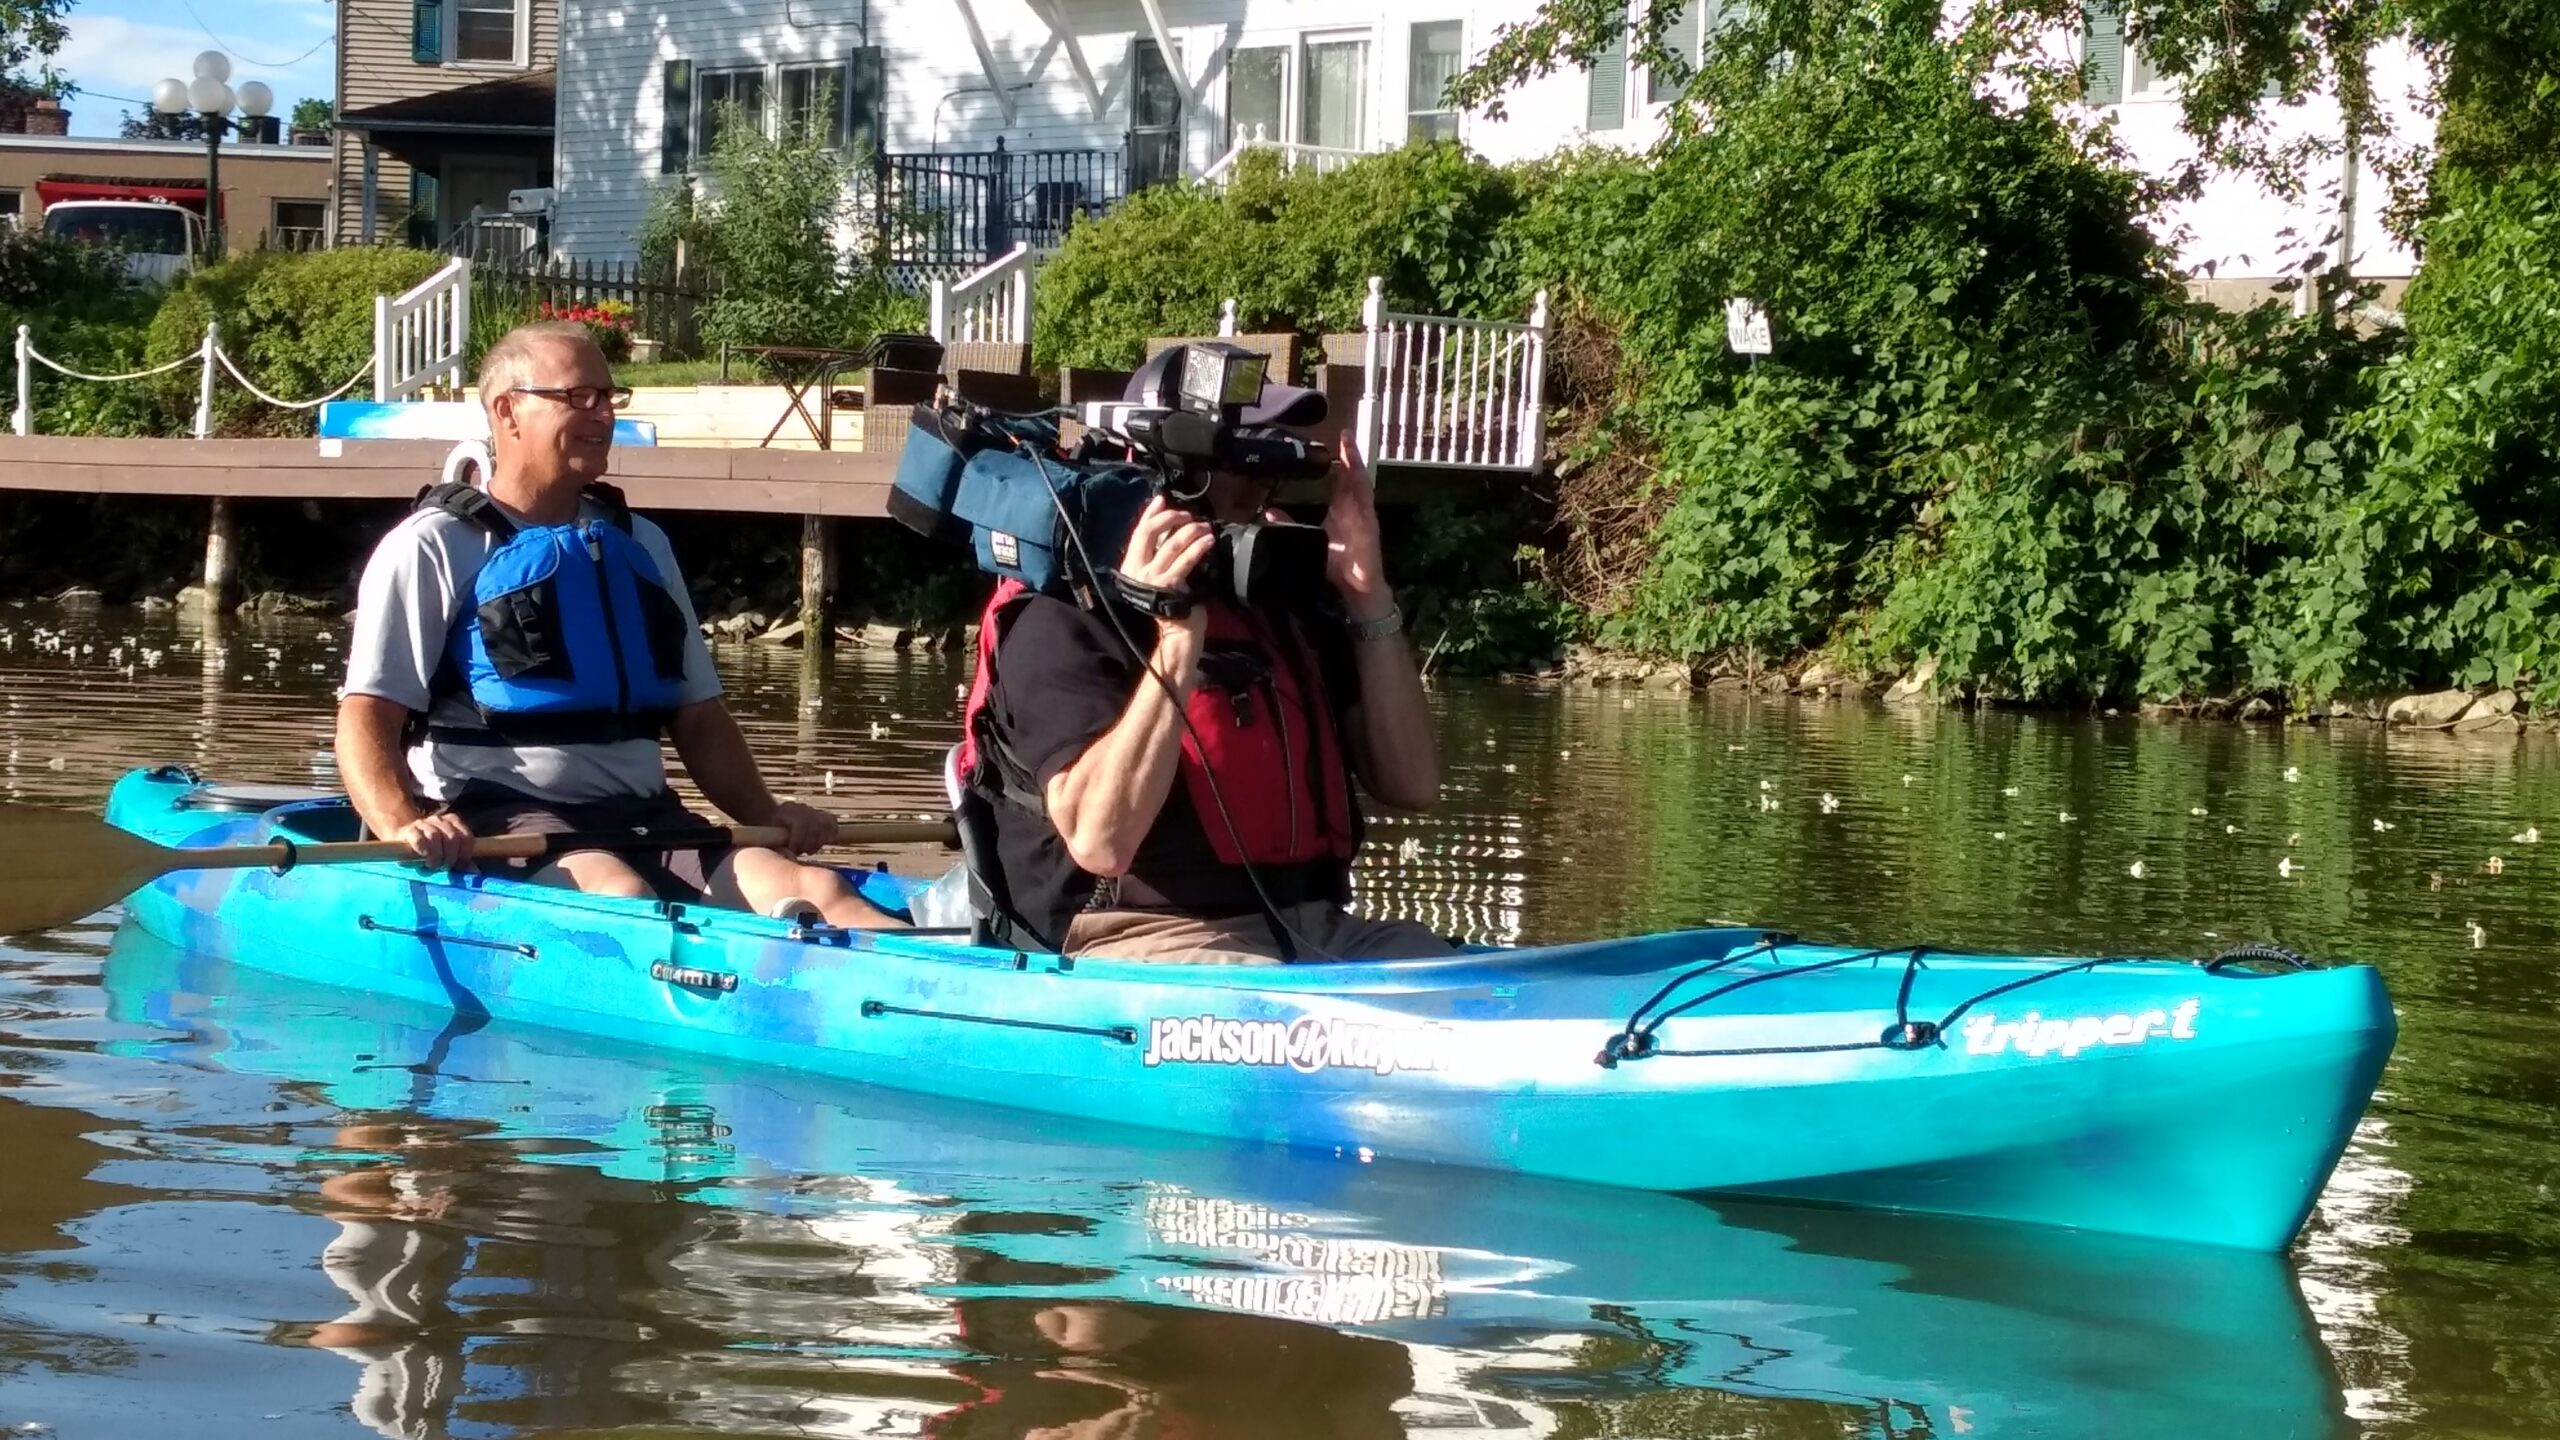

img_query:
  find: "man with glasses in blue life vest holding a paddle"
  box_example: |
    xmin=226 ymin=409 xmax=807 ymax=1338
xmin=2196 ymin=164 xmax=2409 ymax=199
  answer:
xmin=338 ymin=323 xmax=893 ymax=928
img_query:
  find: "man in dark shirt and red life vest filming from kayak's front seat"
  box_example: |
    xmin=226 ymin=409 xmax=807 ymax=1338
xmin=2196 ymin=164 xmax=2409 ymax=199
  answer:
xmin=962 ymin=348 xmax=1449 ymax=963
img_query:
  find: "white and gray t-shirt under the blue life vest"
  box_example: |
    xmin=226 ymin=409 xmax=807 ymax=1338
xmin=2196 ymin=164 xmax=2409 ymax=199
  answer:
xmin=338 ymin=505 xmax=719 ymax=802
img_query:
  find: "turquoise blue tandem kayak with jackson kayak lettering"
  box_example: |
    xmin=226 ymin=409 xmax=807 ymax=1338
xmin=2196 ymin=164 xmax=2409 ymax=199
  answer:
xmin=108 ymin=769 xmax=2396 ymax=1250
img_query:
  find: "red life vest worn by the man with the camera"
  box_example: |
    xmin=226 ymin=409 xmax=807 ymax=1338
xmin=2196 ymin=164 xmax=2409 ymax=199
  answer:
xmin=960 ymin=579 xmax=1359 ymax=866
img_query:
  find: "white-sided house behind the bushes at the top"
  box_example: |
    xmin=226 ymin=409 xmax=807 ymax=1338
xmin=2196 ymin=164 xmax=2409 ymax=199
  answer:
xmin=545 ymin=0 xmax=2427 ymax=297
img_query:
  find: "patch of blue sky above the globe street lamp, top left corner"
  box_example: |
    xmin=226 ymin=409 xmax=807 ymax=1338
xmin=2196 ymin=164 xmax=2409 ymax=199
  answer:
xmin=54 ymin=0 xmax=338 ymax=136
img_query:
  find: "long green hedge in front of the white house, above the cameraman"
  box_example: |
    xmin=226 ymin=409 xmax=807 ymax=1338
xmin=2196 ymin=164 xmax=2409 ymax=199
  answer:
xmin=1032 ymin=143 xmax=1518 ymax=369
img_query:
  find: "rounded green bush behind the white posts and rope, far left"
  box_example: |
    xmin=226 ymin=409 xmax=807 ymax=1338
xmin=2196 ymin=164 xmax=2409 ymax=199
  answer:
xmin=148 ymin=246 xmax=445 ymax=436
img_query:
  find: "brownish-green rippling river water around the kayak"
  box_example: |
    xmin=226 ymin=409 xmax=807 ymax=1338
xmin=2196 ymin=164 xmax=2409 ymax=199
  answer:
xmin=0 ymin=607 xmax=2560 ymax=1440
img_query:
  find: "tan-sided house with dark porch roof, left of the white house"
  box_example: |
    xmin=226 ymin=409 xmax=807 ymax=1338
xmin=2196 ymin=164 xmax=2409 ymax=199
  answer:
xmin=330 ymin=0 xmax=561 ymax=249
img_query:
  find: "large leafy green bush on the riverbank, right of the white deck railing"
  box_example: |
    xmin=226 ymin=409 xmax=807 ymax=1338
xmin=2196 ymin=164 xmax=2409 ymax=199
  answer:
xmin=1505 ymin=5 xmax=2376 ymax=700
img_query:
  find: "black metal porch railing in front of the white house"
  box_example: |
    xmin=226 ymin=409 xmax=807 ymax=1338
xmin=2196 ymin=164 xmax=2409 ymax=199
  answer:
xmin=878 ymin=141 xmax=1129 ymax=266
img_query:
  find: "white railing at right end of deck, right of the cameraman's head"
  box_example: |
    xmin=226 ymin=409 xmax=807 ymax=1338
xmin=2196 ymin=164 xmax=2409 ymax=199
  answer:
xmin=1357 ymin=274 xmax=1546 ymax=469
